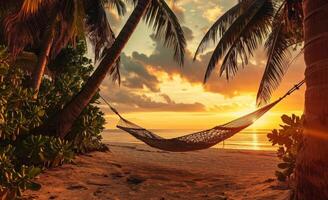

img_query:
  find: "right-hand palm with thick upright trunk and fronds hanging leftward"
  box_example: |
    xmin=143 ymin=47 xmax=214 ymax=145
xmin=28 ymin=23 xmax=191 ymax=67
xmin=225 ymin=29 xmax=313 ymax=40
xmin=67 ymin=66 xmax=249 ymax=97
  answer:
xmin=195 ymin=0 xmax=328 ymax=199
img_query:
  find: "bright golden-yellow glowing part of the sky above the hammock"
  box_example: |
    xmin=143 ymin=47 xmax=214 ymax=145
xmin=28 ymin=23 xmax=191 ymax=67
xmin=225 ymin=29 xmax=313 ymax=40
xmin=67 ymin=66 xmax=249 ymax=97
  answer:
xmin=103 ymin=66 xmax=304 ymax=130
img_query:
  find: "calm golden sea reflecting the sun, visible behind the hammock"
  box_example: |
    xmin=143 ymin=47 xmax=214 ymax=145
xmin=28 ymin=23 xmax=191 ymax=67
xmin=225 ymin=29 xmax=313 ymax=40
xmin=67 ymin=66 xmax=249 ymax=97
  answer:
xmin=102 ymin=129 xmax=277 ymax=151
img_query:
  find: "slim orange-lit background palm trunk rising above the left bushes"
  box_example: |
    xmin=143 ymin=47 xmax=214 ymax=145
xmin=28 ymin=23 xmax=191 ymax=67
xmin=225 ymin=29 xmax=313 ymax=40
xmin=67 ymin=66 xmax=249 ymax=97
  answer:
xmin=32 ymin=11 xmax=57 ymax=98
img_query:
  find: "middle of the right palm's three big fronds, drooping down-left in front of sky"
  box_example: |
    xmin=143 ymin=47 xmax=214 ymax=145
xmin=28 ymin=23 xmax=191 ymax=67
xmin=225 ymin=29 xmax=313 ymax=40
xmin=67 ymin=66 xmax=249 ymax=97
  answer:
xmin=204 ymin=0 xmax=274 ymax=82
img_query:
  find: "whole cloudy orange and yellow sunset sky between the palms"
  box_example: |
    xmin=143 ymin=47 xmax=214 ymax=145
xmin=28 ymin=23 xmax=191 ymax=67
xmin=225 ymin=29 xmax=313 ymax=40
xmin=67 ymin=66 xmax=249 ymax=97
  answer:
xmin=97 ymin=0 xmax=305 ymax=129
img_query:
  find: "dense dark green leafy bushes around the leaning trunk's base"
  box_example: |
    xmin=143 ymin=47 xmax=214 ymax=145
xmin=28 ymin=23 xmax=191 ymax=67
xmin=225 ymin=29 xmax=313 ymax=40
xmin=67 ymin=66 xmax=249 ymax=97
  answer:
xmin=0 ymin=42 xmax=106 ymax=199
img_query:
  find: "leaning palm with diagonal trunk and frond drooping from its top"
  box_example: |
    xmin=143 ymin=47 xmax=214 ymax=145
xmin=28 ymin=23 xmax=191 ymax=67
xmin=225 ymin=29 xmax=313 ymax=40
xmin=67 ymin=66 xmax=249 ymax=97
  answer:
xmin=34 ymin=0 xmax=186 ymax=138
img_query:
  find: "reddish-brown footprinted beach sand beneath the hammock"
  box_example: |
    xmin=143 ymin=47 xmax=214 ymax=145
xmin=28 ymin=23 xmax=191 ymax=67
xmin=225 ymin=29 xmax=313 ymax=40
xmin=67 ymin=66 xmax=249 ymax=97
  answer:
xmin=24 ymin=143 xmax=289 ymax=200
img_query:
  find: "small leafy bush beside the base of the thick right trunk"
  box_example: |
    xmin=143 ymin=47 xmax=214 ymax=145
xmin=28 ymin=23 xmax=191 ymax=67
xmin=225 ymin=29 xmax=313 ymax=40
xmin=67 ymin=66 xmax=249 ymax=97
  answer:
xmin=268 ymin=114 xmax=303 ymax=181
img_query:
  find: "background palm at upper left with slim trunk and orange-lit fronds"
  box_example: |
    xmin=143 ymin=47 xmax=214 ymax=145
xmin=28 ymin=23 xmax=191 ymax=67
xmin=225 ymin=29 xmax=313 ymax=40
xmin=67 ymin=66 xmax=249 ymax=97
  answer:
xmin=0 ymin=0 xmax=126 ymax=94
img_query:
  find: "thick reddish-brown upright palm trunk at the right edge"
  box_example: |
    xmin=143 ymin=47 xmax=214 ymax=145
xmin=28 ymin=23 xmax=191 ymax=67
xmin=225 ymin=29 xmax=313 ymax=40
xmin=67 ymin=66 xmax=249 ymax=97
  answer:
xmin=295 ymin=0 xmax=328 ymax=200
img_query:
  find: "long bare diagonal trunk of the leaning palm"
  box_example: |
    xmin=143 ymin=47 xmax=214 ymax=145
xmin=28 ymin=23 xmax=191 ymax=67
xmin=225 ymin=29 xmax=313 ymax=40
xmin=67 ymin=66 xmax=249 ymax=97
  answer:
xmin=34 ymin=0 xmax=151 ymax=138
